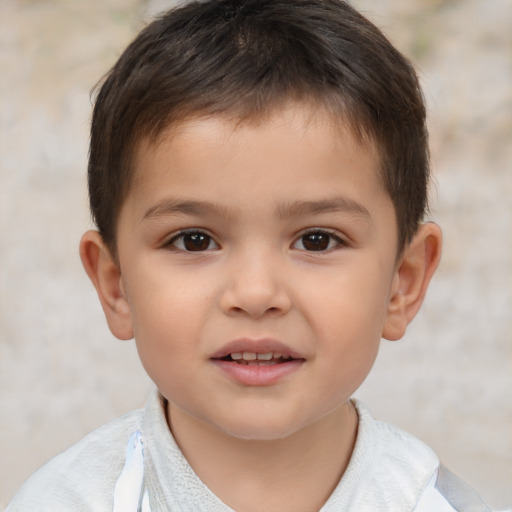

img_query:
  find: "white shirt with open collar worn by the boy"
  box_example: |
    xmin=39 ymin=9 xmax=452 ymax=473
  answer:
xmin=6 ymin=391 xmax=490 ymax=512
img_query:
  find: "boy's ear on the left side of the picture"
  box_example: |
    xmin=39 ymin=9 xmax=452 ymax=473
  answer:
xmin=80 ymin=231 xmax=133 ymax=340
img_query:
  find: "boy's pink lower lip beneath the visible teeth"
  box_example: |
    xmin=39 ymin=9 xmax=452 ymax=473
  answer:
xmin=212 ymin=359 xmax=304 ymax=386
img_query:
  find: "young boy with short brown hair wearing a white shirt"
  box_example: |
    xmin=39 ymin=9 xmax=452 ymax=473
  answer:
xmin=8 ymin=0 xmax=489 ymax=512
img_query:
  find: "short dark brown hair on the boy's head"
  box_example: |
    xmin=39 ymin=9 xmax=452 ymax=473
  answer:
xmin=88 ymin=0 xmax=430 ymax=252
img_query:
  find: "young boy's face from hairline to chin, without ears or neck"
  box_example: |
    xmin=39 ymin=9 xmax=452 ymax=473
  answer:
xmin=117 ymin=106 xmax=397 ymax=439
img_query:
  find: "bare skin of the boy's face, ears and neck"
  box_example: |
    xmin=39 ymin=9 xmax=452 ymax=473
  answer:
xmin=81 ymin=105 xmax=441 ymax=512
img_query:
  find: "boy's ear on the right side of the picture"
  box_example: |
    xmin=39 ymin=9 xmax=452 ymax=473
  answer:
xmin=382 ymin=222 xmax=442 ymax=341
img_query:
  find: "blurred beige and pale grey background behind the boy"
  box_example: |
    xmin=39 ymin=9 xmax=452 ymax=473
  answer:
xmin=0 ymin=0 xmax=512 ymax=509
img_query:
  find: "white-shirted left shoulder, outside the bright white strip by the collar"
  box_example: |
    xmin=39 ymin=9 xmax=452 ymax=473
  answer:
xmin=6 ymin=410 xmax=143 ymax=512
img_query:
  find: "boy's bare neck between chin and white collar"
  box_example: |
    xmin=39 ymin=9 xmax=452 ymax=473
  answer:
xmin=167 ymin=402 xmax=358 ymax=512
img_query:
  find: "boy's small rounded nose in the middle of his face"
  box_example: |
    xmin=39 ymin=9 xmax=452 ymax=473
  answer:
xmin=220 ymin=253 xmax=291 ymax=319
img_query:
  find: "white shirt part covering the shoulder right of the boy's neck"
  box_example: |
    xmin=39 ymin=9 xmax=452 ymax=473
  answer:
xmin=332 ymin=401 xmax=490 ymax=512
